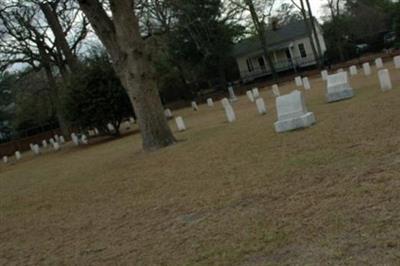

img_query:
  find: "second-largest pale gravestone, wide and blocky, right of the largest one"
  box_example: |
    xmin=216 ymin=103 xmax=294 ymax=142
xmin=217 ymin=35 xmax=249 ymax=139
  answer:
xmin=326 ymin=72 xmax=354 ymax=103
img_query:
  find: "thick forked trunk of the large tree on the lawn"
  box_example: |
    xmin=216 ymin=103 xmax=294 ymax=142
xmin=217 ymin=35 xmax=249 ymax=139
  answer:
xmin=79 ymin=0 xmax=176 ymax=150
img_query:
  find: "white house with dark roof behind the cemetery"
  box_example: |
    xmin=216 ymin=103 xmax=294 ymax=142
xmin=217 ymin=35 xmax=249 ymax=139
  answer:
xmin=233 ymin=20 xmax=326 ymax=81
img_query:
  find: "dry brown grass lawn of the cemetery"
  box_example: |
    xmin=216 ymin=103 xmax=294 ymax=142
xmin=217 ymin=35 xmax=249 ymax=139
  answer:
xmin=0 ymin=62 xmax=400 ymax=265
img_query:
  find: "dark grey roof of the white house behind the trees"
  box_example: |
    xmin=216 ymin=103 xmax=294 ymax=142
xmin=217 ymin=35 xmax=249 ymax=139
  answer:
xmin=233 ymin=20 xmax=308 ymax=57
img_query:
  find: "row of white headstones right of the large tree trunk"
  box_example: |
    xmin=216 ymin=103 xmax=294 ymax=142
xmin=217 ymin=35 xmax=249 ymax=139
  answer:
xmin=169 ymin=56 xmax=400 ymax=133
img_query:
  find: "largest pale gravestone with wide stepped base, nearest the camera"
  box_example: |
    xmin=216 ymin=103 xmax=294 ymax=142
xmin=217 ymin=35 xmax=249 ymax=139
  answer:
xmin=274 ymin=90 xmax=315 ymax=133
